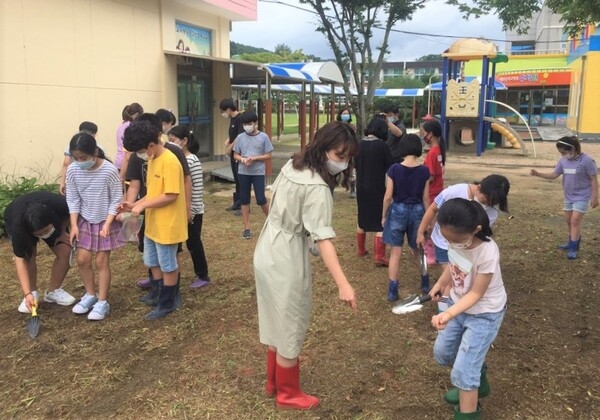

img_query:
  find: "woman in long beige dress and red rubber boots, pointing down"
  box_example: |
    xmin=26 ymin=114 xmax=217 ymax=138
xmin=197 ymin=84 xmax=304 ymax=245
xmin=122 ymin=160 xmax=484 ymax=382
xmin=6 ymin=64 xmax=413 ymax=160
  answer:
xmin=254 ymin=121 xmax=358 ymax=409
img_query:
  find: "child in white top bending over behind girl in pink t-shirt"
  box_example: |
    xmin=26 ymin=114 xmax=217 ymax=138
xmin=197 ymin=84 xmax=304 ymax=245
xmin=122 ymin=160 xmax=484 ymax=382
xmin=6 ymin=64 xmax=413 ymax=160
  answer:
xmin=417 ymin=174 xmax=510 ymax=310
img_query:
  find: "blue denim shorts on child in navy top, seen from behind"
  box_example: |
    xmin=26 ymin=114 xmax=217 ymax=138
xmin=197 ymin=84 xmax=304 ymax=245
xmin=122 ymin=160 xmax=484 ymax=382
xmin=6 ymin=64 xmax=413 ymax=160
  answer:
xmin=383 ymin=202 xmax=425 ymax=249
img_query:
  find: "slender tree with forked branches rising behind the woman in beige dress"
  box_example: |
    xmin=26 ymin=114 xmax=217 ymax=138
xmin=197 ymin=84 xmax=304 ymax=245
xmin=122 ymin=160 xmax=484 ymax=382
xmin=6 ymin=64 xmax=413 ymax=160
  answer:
xmin=300 ymin=0 xmax=426 ymax=133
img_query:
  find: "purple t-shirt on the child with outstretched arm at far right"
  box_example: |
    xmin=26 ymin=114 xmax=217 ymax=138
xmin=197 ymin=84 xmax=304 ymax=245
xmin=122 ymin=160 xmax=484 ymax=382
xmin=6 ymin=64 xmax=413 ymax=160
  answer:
xmin=554 ymin=153 xmax=598 ymax=203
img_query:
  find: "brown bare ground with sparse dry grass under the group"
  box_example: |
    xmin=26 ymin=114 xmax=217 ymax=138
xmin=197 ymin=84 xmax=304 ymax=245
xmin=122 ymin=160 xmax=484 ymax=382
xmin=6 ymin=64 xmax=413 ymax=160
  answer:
xmin=0 ymin=143 xmax=600 ymax=419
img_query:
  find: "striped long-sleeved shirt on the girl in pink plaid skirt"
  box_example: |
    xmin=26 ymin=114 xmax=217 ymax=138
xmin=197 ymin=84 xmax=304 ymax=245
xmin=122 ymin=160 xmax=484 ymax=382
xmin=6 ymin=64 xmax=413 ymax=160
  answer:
xmin=67 ymin=160 xmax=123 ymax=224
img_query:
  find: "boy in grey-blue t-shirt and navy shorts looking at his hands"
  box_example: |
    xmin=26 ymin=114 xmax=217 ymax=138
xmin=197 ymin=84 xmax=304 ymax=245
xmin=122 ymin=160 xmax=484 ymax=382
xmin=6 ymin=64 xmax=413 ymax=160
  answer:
xmin=233 ymin=111 xmax=273 ymax=239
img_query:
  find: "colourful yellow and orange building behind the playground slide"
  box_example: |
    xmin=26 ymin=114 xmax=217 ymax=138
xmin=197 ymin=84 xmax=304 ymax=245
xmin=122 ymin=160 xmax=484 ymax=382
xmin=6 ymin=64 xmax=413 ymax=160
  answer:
xmin=464 ymin=7 xmax=600 ymax=139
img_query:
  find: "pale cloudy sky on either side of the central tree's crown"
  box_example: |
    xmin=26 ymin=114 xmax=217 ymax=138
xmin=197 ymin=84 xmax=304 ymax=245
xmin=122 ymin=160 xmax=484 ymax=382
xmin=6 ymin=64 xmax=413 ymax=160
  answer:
xmin=231 ymin=0 xmax=504 ymax=61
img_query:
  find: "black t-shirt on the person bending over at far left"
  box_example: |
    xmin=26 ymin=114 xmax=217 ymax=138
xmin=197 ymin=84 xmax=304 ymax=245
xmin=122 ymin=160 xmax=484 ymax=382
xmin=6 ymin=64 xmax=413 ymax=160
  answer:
xmin=4 ymin=191 xmax=69 ymax=259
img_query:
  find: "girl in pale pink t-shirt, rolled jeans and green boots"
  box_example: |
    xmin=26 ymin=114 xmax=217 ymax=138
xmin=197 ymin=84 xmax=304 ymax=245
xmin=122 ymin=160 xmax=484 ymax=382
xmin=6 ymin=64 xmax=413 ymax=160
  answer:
xmin=430 ymin=198 xmax=506 ymax=418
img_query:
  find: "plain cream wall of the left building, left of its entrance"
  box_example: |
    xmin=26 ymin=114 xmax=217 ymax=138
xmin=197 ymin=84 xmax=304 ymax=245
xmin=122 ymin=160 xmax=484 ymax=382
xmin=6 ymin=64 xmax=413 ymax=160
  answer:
xmin=0 ymin=0 xmax=162 ymax=176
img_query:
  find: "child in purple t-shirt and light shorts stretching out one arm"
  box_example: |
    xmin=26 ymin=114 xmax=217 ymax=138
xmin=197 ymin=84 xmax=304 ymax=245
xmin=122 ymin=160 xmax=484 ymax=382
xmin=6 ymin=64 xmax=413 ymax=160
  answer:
xmin=530 ymin=136 xmax=598 ymax=260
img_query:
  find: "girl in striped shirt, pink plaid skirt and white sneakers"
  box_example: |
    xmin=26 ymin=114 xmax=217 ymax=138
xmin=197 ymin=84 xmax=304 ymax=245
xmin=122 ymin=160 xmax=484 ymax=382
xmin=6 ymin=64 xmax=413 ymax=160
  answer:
xmin=67 ymin=132 xmax=124 ymax=321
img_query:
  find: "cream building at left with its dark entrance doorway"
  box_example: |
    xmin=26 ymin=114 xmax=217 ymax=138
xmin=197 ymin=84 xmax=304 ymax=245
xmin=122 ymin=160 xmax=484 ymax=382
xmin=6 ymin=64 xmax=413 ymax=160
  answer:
xmin=0 ymin=0 xmax=257 ymax=176
